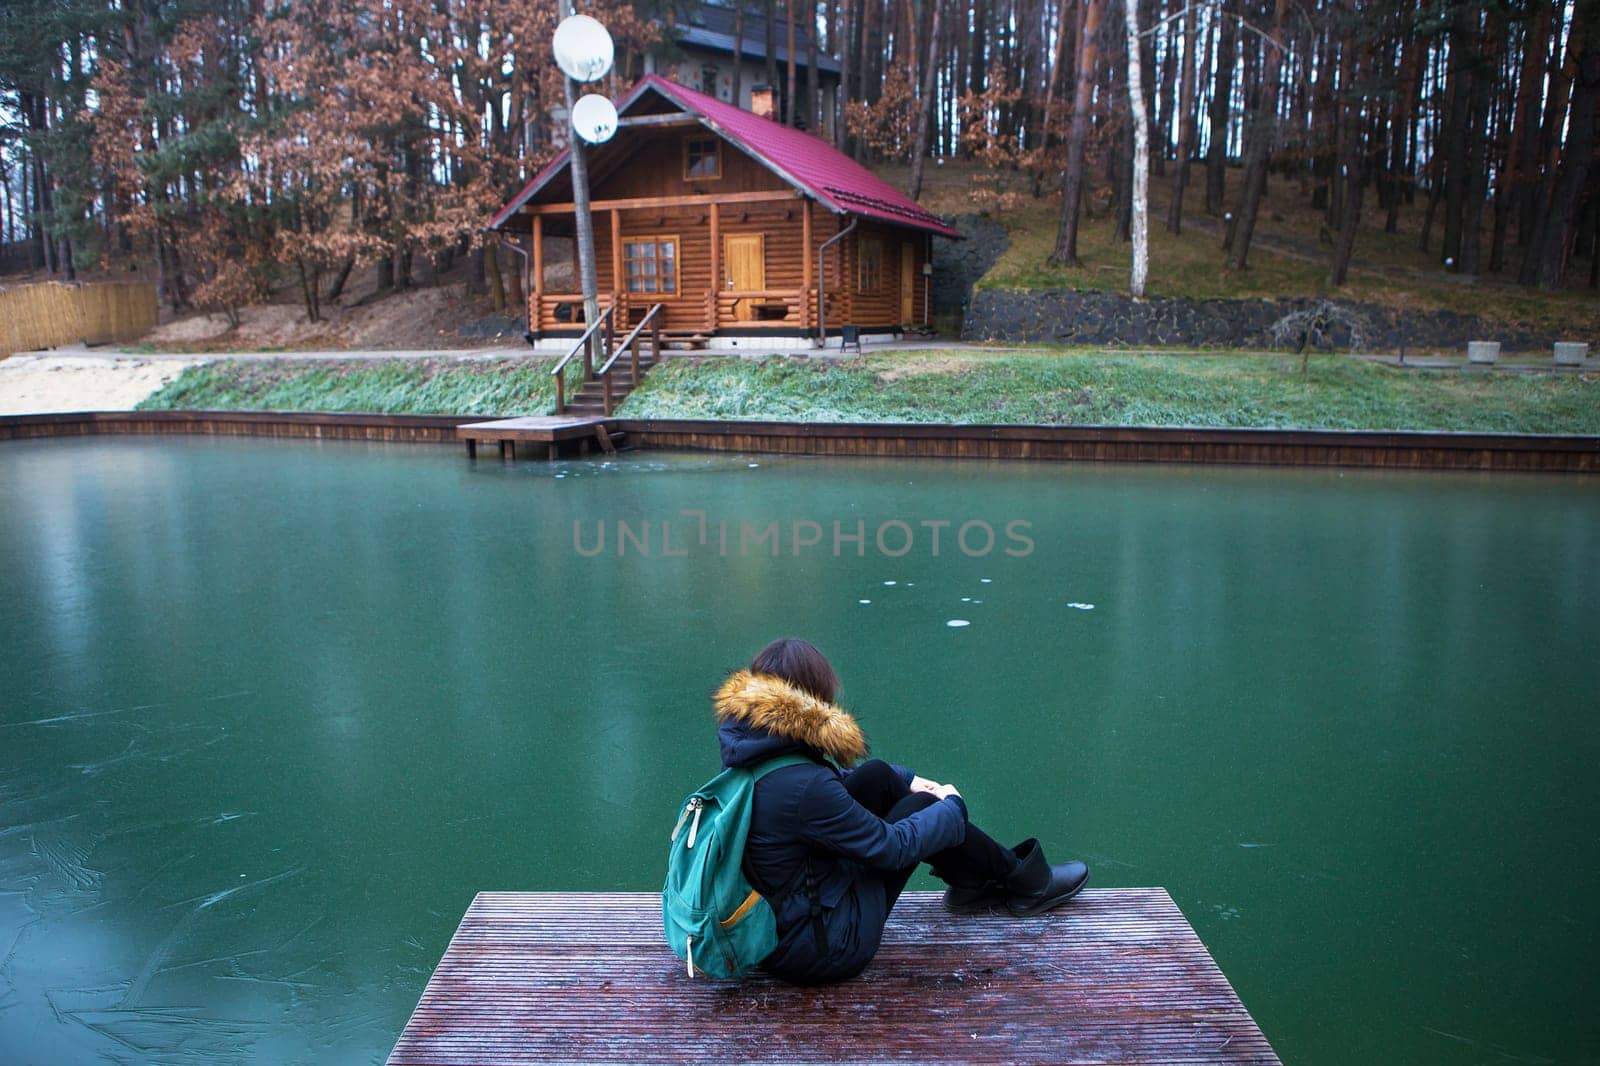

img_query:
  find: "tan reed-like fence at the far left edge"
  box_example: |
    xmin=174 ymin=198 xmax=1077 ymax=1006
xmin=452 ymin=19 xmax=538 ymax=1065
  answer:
xmin=0 ymin=282 xmax=157 ymax=359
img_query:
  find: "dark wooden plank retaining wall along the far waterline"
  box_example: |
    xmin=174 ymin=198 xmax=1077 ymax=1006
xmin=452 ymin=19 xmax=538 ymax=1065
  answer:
xmin=0 ymin=411 xmax=1600 ymax=474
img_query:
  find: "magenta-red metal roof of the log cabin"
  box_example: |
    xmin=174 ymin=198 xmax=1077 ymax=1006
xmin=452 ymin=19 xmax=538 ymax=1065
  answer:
xmin=490 ymin=74 xmax=962 ymax=238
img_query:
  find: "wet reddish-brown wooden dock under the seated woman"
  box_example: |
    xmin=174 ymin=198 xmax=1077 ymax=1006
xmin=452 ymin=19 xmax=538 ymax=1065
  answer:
xmin=389 ymin=888 xmax=1278 ymax=1066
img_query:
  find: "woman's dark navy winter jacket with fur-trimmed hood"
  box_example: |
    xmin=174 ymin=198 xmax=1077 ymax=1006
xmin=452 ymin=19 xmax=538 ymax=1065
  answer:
xmin=714 ymin=671 xmax=966 ymax=984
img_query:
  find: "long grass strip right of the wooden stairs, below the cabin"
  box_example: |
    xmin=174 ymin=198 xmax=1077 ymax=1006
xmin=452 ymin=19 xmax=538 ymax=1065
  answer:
xmin=618 ymin=351 xmax=1600 ymax=434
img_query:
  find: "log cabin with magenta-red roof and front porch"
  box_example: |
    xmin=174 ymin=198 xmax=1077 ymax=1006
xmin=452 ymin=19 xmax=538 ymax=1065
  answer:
xmin=490 ymin=75 xmax=960 ymax=347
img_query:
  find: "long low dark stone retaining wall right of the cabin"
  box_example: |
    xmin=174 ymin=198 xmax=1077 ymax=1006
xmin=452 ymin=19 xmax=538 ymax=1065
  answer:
xmin=962 ymin=290 xmax=1600 ymax=352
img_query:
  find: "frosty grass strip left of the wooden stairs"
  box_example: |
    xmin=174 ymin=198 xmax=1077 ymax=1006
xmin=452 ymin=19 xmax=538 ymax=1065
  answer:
xmin=139 ymin=359 xmax=555 ymax=416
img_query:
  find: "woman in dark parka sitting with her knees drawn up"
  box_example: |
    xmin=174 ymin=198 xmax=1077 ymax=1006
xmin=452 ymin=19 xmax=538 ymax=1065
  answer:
xmin=714 ymin=639 xmax=1090 ymax=984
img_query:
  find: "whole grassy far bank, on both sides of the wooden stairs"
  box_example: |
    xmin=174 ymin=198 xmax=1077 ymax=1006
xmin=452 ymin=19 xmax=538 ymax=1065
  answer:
xmin=139 ymin=351 xmax=1600 ymax=434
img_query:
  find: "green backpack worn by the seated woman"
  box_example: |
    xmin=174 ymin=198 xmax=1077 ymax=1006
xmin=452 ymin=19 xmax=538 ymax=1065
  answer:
xmin=661 ymin=755 xmax=810 ymax=978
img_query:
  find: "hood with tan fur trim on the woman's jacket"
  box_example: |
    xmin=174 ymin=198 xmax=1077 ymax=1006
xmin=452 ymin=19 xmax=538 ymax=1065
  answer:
xmin=712 ymin=671 xmax=867 ymax=767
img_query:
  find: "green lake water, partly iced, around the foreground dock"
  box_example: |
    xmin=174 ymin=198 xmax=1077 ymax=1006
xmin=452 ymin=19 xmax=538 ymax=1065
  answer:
xmin=0 ymin=439 xmax=1600 ymax=1066
